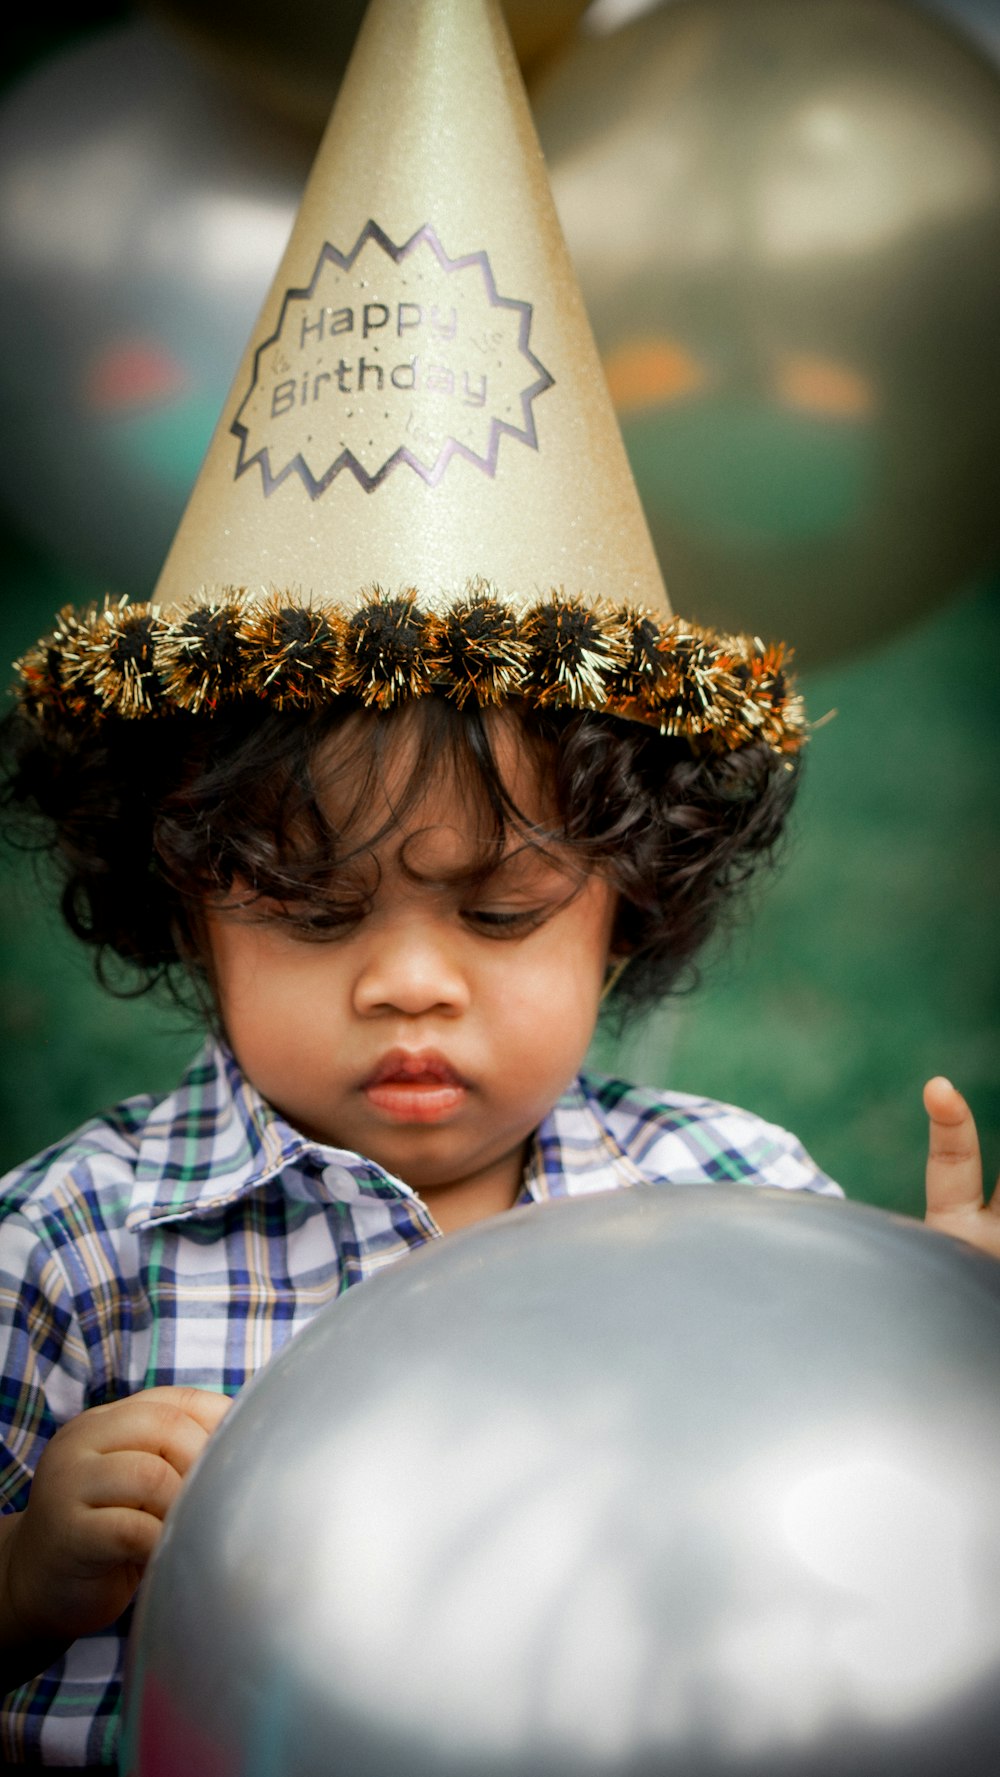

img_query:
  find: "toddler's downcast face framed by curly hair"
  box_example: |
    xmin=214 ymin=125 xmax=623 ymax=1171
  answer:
xmin=206 ymin=727 xmax=615 ymax=1230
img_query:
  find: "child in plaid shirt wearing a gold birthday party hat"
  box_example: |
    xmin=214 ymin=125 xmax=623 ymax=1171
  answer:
xmin=0 ymin=0 xmax=996 ymax=1766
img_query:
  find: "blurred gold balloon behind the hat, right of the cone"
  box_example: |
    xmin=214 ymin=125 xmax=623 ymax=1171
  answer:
xmin=533 ymin=0 xmax=1000 ymax=665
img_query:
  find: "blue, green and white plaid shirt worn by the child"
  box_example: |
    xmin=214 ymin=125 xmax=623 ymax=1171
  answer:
xmin=0 ymin=1043 xmax=838 ymax=1766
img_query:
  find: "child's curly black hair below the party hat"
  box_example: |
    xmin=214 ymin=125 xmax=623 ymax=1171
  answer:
xmin=0 ymin=697 xmax=798 ymax=1022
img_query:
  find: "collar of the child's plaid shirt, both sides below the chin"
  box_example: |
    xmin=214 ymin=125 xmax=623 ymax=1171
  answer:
xmin=128 ymin=1040 xmax=643 ymax=1231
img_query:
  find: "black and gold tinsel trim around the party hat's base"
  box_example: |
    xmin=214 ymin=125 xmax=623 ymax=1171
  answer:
xmin=16 ymin=583 xmax=808 ymax=753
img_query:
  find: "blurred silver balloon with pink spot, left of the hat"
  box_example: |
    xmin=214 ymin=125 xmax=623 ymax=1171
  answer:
xmin=0 ymin=23 xmax=313 ymax=597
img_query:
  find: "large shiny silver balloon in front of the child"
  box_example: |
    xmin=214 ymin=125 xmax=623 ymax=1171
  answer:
xmin=121 ymin=1187 xmax=1000 ymax=1777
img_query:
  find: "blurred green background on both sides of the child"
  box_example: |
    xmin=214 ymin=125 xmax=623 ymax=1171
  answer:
xmin=0 ymin=5 xmax=1000 ymax=1214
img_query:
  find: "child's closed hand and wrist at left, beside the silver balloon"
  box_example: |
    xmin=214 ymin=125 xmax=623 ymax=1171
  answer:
xmin=0 ymin=1388 xmax=229 ymax=1647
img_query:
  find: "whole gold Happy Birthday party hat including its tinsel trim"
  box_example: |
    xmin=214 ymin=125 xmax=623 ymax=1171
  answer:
xmin=20 ymin=0 xmax=803 ymax=750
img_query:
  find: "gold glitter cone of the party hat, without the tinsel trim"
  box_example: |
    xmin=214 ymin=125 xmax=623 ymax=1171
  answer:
xmin=155 ymin=0 xmax=664 ymax=625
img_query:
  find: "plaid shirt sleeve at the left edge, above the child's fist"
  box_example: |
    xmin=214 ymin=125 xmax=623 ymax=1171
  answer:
xmin=0 ymin=1212 xmax=87 ymax=1512
